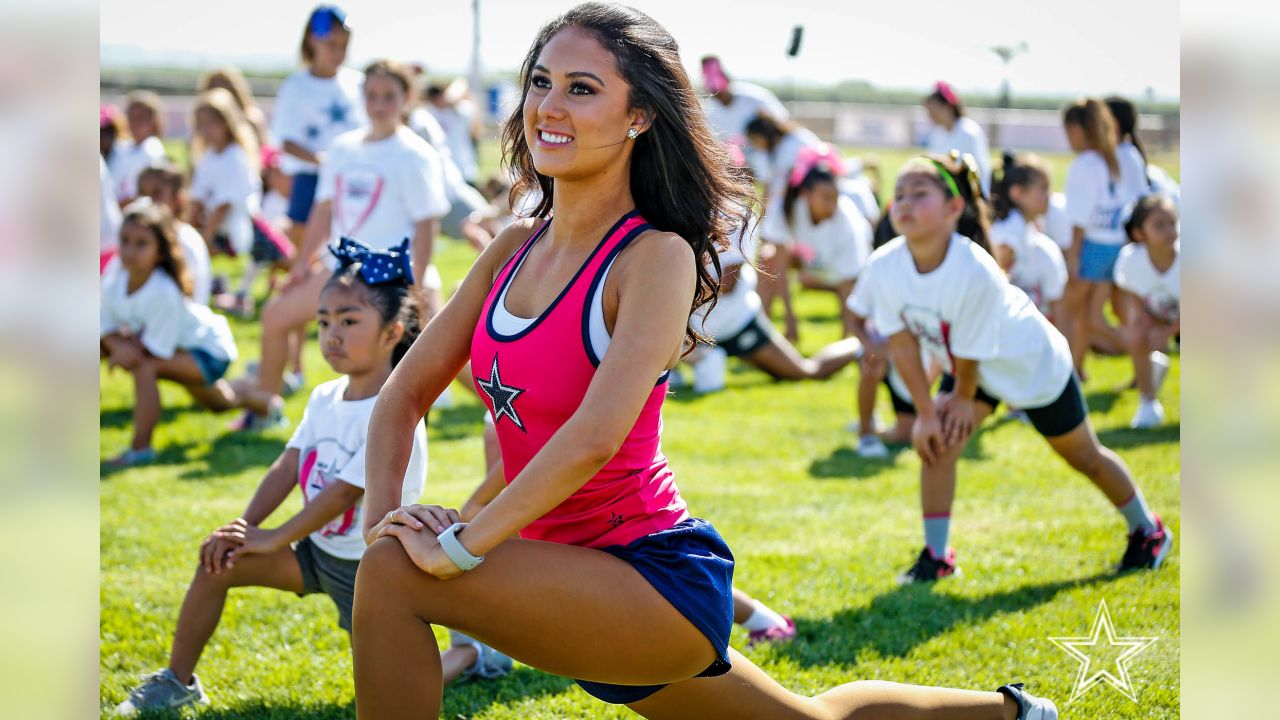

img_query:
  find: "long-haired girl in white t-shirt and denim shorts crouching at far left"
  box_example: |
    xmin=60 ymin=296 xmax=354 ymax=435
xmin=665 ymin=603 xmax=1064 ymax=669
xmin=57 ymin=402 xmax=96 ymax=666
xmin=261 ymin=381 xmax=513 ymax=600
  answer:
xmin=100 ymin=201 xmax=236 ymax=468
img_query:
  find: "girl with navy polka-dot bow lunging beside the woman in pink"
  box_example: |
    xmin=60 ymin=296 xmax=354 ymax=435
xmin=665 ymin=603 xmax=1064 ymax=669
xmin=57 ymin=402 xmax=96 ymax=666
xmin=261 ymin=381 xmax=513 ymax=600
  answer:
xmin=116 ymin=241 xmax=509 ymax=715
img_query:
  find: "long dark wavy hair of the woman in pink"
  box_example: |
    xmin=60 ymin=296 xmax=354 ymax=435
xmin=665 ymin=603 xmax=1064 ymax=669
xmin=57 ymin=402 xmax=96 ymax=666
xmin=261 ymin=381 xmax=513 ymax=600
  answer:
xmin=502 ymin=3 xmax=755 ymax=350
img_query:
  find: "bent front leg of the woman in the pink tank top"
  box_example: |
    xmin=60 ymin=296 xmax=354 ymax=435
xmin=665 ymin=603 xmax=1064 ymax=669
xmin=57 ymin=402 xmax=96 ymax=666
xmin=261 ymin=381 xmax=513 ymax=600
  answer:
xmin=353 ymin=530 xmax=716 ymax=719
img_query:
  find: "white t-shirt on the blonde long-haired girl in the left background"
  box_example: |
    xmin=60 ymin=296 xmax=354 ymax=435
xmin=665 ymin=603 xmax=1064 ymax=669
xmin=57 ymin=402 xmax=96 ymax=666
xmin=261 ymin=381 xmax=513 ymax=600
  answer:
xmin=191 ymin=143 xmax=262 ymax=255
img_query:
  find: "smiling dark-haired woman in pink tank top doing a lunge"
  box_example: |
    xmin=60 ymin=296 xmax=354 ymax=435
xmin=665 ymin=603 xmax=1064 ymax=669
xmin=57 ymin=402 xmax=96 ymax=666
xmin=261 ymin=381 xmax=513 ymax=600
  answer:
xmin=353 ymin=3 xmax=1056 ymax=720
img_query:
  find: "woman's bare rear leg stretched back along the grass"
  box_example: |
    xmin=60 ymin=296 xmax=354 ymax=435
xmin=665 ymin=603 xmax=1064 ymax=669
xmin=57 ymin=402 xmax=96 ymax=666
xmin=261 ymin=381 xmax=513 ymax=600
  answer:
xmin=627 ymin=650 xmax=1018 ymax=720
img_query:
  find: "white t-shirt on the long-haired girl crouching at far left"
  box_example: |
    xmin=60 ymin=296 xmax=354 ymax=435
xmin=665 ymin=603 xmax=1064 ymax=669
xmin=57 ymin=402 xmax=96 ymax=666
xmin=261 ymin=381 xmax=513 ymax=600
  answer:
xmin=99 ymin=268 xmax=237 ymax=361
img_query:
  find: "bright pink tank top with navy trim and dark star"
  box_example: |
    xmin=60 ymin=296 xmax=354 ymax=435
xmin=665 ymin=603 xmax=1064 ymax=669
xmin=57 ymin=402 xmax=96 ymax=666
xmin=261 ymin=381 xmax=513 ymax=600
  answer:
xmin=471 ymin=210 xmax=689 ymax=547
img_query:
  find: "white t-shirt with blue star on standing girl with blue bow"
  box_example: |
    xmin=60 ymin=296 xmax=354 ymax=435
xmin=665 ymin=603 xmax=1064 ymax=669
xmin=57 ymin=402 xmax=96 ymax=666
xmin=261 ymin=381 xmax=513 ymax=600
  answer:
xmin=271 ymin=68 xmax=369 ymax=176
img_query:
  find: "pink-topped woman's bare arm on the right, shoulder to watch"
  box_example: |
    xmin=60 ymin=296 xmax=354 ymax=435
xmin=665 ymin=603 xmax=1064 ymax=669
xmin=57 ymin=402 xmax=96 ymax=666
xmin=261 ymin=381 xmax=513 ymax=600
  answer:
xmin=457 ymin=233 xmax=696 ymax=555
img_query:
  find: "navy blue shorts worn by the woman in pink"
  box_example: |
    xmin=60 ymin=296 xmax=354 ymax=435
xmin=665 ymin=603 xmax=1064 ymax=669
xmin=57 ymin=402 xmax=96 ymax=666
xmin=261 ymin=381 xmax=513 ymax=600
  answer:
xmin=576 ymin=518 xmax=733 ymax=705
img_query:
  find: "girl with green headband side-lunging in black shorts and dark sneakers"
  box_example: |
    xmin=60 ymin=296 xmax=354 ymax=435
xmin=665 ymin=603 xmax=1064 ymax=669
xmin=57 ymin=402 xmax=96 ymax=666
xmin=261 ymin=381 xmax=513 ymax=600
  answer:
xmin=863 ymin=158 xmax=1174 ymax=583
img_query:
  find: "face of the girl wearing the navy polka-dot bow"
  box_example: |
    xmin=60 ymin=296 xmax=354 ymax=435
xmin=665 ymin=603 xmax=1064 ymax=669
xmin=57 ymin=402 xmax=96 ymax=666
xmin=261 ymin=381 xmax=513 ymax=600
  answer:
xmin=316 ymin=283 xmax=399 ymax=375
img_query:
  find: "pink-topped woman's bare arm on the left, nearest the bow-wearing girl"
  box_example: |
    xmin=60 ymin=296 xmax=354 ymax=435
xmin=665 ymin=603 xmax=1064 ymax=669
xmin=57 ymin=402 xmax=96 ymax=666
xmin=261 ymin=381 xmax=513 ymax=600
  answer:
xmin=364 ymin=222 xmax=537 ymax=537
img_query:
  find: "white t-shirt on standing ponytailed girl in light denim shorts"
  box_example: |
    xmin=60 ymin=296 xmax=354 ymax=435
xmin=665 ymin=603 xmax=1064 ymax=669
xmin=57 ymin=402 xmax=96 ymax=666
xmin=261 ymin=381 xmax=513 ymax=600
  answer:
xmin=1066 ymin=150 xmax=1139 ymax=245
